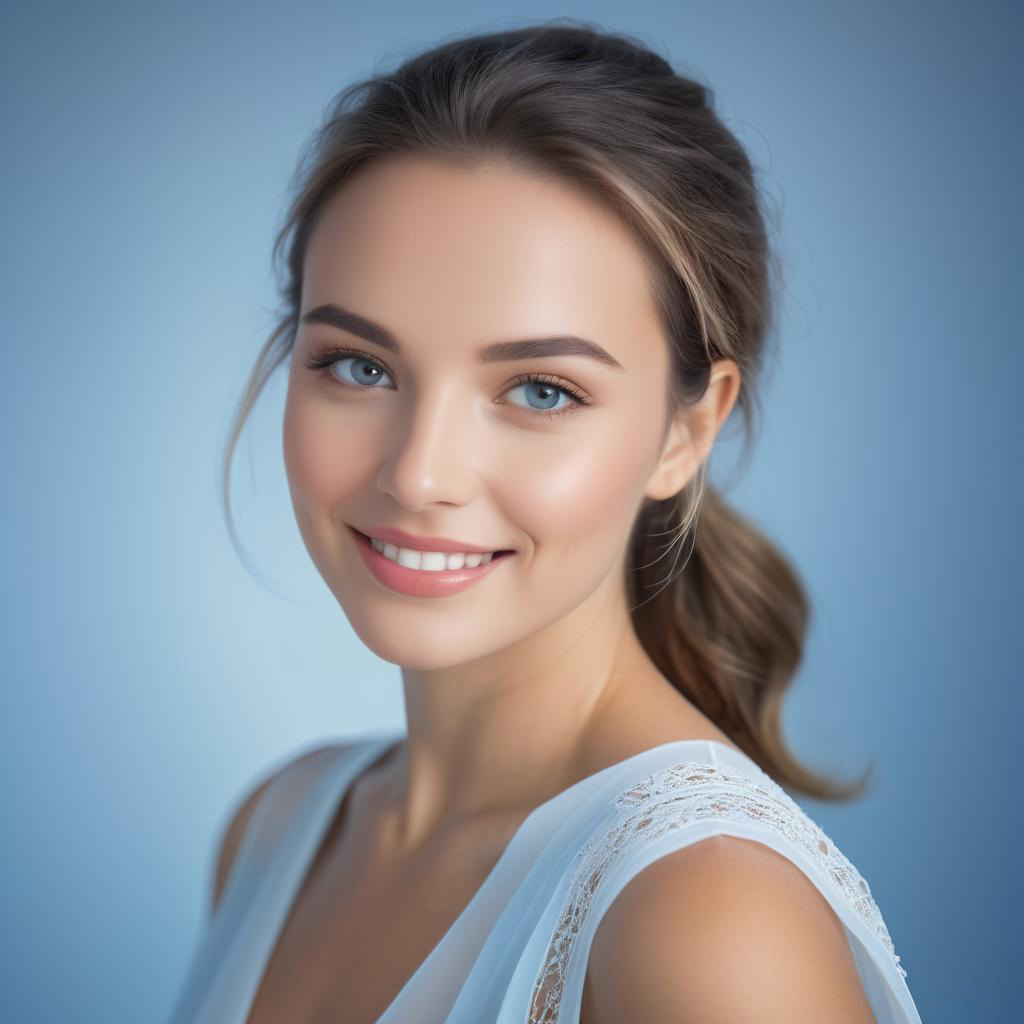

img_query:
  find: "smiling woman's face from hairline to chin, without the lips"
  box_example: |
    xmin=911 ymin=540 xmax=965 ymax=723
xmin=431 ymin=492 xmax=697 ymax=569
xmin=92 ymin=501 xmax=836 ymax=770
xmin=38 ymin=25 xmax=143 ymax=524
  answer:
xmin=284 ymin=149 xmax=699 ymax=670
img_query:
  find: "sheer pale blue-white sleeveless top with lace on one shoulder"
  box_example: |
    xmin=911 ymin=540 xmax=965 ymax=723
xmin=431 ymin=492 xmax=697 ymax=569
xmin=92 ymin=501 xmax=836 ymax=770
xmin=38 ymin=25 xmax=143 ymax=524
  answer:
xmin=168 ymin=733 xmax=921 ymax=1024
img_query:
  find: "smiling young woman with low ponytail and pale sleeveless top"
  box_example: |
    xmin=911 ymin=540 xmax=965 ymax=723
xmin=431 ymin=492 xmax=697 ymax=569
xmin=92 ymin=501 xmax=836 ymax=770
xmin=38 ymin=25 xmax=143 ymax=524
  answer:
xmin=165 ymin=18 xmax=920 ymax=1024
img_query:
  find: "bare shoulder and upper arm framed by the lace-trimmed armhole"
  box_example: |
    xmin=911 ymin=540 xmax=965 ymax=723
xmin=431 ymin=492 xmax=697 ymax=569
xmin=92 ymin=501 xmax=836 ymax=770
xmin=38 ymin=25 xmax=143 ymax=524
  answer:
xmin=581 ymin=836 xmax=876 ymax=1024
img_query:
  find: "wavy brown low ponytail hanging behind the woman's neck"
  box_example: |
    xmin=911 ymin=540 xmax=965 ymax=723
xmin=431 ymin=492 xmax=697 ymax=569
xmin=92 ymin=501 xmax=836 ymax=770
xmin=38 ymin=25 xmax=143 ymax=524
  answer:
xmin=627 ymin=485 xmax=866 ymax=800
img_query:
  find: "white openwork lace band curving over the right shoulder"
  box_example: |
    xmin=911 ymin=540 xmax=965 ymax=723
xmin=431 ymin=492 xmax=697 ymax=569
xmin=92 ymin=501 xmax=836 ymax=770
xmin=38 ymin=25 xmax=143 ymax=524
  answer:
xmin=528 ymin=761 xmax=906 ymax=1024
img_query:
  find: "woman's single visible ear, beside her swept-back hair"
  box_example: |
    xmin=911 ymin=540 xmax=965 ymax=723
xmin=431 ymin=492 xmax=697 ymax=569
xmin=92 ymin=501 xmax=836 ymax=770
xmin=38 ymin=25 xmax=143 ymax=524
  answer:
xmin=645 ymin=359 xmax=740 ymax=501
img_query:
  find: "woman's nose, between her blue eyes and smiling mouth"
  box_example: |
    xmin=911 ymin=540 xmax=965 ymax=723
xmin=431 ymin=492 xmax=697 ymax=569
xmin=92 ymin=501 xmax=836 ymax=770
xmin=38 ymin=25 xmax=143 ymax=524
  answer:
xmin=377 ymin=379 xmax=480 ymax=510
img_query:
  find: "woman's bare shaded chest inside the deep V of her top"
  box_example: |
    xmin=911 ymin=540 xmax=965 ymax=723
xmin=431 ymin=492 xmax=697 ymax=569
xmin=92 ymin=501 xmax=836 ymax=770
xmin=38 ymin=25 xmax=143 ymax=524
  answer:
xmin=246 ymin=815 xmax=520 ymax=1024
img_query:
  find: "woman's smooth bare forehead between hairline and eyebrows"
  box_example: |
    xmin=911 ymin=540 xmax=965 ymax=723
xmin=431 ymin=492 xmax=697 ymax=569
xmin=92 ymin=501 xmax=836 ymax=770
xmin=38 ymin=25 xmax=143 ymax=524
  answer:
xmin=302 ymin=156 xmax=658 ymax=364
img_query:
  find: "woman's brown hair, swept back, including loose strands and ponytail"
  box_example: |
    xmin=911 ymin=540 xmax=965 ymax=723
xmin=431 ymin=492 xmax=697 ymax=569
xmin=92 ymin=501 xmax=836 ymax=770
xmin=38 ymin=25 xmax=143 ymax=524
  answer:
xmin=222 ymin=18 xmax=873 ymax=800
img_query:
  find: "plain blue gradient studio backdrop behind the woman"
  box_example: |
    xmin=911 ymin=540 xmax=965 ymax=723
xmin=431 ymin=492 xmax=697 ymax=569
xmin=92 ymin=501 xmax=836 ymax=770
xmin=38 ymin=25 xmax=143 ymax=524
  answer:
xmin=0 ymin=0 xmax=1024 ymax=1024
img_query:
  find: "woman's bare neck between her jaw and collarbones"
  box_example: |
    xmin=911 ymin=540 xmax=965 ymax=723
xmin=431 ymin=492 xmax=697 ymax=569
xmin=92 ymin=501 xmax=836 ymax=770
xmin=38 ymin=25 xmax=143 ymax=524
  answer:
xmin=380 ymin=581 xmax=669 ymax=851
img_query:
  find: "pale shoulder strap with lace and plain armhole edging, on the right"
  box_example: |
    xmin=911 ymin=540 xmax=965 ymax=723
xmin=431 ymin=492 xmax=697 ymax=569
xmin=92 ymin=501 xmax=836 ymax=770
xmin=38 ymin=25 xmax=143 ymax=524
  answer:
xmin=529 ymin=760 xmax=920 ymax=1021
